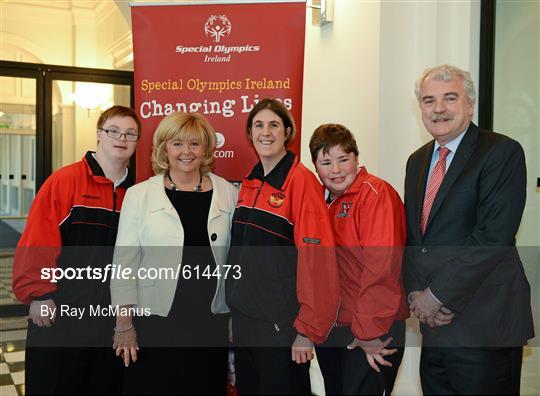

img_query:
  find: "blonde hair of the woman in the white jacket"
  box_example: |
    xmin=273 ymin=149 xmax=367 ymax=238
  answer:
xmin=152 ymin=112 xmax=216 ymax=175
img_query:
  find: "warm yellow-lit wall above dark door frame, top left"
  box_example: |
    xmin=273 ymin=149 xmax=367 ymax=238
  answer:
xmin=0 ymin=0 xmax=131 ymax=69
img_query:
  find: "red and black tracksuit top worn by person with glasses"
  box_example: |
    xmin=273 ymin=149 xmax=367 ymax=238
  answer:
xmin=13 ymin=152 xmax=132 ymax=306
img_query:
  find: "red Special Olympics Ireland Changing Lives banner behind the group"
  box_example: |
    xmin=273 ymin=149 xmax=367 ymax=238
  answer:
xmin=131 ymin=1 xmax=306 ymax=181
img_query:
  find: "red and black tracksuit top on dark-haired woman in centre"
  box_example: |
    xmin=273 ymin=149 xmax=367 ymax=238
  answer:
xmin=226 ymin=152 xmax=340 ymax=343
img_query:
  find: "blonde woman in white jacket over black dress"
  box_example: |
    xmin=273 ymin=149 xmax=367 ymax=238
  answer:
xmin=111 ymin=113 xmax=236 ymax=394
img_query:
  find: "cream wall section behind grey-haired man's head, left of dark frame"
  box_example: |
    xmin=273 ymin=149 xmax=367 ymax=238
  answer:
xmin=378 ymin=1 xmax=480 ymax=194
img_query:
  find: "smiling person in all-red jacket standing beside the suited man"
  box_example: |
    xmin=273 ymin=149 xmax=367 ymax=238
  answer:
xmin=309 ymin=124 xmax=409 ymax=395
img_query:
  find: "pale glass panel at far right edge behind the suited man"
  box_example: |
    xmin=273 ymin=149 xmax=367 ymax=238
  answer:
xmin=493 ymin=1 xmax=540 ymax=395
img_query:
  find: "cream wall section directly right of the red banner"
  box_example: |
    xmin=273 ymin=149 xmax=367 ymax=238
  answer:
xmin=301 ymin=1 xmax=380 ymax=174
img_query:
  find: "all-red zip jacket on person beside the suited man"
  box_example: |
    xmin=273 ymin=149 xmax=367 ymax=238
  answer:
xmin=328 ymin=167 xmax=409 ymax=340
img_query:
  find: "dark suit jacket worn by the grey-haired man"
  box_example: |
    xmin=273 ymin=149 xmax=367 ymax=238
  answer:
xmin=403 ymin=123 xmax=534 ymax=347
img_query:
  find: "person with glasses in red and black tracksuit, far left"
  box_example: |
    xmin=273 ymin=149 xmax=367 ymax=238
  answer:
xmin=13 ymin=106 xmax=141 ymax=395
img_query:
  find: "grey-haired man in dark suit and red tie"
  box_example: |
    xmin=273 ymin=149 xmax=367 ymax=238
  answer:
xmin=403 ymin=65 xmax=534 ymax=394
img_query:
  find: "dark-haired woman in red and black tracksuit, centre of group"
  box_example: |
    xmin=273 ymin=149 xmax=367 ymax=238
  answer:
xmin=226 ymin=99 xmax=340 ymax=394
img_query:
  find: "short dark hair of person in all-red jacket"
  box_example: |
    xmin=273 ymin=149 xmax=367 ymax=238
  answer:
xmin=309 ymin=124 xmax=358 ymax=164
